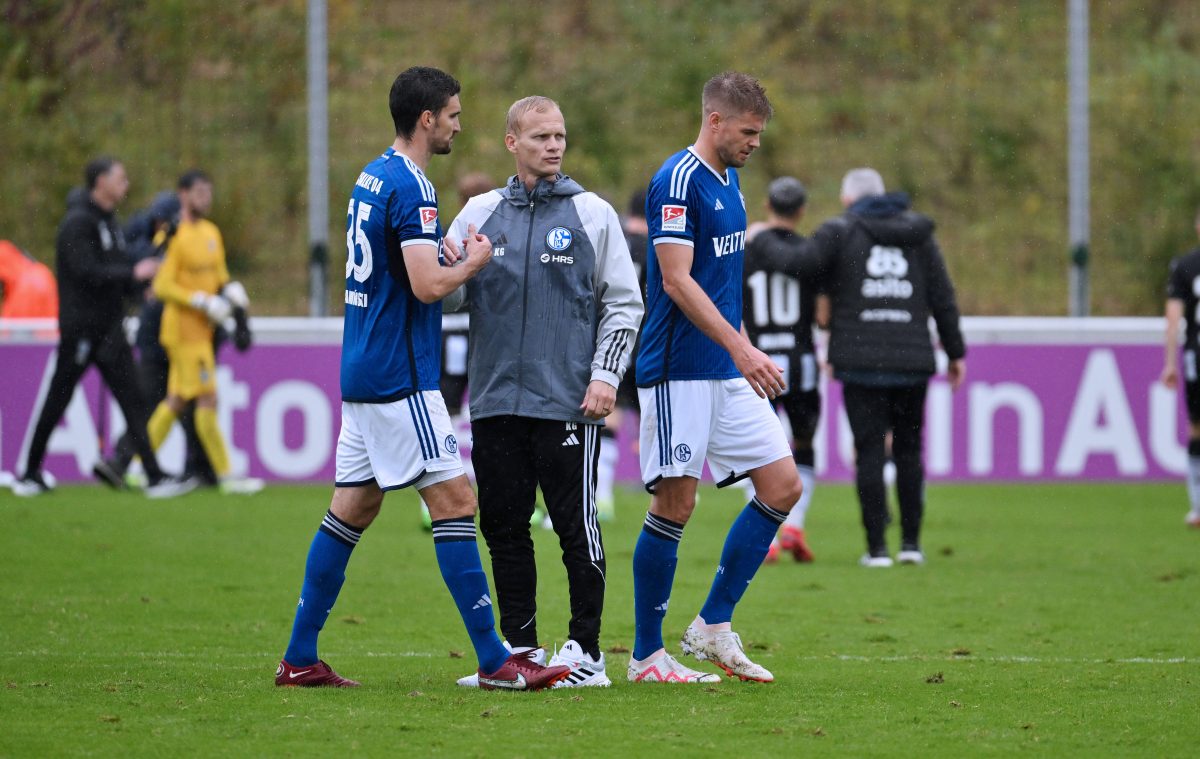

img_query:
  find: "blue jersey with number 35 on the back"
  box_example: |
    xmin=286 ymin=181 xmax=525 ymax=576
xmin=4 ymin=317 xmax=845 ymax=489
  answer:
xmin=342 ymin=148 xmax=442 ymax=404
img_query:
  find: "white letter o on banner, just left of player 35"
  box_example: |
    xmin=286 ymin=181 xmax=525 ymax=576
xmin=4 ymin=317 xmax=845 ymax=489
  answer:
xmin=254 ymin=380 xmax=335 ymax=479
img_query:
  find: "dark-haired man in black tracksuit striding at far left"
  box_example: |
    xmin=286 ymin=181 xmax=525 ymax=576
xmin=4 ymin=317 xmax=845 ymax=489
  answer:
xmin=12 ymin=156 xmax=192 ymax=497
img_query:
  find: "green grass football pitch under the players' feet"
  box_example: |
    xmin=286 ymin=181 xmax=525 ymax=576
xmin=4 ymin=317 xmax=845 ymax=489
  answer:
xmin=0 ymin=485 xmax=1200 ymax=757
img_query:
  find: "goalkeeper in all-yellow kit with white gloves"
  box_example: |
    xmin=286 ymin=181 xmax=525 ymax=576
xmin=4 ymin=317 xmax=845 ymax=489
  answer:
xmin=148 ymin=169 xmax=263 ymax=492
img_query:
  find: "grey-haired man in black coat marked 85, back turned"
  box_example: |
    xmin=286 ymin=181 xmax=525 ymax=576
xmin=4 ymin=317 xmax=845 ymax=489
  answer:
xmin=814 ymin=168 xmax=966 ymax=567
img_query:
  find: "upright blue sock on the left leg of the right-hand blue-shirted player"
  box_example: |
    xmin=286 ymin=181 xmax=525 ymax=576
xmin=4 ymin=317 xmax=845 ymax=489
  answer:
xmin=634 ymin=514 xmax=683 ymax=659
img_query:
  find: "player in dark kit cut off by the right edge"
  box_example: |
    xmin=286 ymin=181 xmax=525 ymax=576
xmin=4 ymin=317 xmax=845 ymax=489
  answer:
xmin=1163 ymin=204 xmax=1200 ymax=527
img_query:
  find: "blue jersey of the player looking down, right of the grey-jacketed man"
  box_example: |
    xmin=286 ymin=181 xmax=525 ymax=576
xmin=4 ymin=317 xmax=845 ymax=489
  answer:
xmin=637 ymin=148 xmax=746 ymax=388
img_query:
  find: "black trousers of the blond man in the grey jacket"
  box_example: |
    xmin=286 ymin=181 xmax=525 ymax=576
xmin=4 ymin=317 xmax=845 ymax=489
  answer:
xmin=470 ymin=417 xmax=605 ymax=655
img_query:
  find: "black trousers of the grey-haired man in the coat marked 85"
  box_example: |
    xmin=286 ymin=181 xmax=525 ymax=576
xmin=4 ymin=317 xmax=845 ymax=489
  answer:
xmin=841 ymin=382 xmax=929 ymax=552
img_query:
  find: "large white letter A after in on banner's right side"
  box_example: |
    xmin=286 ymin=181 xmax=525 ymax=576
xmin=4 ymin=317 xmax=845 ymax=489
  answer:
xmin=1055 ymin=348 xmax=1146 ymax=477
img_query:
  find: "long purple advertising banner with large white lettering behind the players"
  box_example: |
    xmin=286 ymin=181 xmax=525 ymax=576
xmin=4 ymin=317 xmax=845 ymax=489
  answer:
xmin=0 ymin=319 xmax=1187 ymax=482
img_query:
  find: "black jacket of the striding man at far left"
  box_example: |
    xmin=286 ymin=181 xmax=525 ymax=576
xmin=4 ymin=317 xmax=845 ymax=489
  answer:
xmin=55 ymin=198 xmax=136 ymax=336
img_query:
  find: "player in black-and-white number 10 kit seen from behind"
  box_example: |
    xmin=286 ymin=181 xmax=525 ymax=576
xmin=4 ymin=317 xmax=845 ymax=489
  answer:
xmin=742 ymin=177 xmax=821 ymax=562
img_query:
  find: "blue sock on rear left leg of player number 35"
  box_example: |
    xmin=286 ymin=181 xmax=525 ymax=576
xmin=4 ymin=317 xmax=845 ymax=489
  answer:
xmin=283 ymin=512 xmax=362 ymax=667
